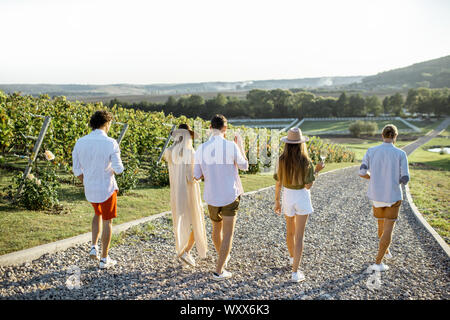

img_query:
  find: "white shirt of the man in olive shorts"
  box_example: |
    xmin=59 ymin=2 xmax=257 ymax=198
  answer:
xmin=194 ymin=135 xmax=248 ymax=207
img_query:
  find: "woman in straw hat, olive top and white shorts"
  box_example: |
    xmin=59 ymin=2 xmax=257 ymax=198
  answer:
xmin=274 ymin=128 xmax=325 ymax=282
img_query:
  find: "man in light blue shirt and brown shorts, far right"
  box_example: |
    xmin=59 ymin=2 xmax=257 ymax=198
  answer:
xmin=359 ymin=124 xmax=409 ymax=271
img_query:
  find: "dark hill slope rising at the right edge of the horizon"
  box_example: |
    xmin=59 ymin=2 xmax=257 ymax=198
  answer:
xmin=352 ymin=56 xmax=450 ymax=90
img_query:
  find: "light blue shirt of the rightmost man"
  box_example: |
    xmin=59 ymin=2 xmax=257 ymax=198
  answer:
xmin=359 ymin=142 xmax=409 ymax=203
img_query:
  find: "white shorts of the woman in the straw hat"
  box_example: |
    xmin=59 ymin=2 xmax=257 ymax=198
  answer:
xmin=281 ymin=187 xmax=314 ymax=217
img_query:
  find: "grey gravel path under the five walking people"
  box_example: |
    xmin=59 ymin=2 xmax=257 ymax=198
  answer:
xmin=0 ymin=167 xmax=450 ymax=300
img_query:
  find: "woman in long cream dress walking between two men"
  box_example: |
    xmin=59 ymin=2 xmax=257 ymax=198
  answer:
xmin=164 ymin=129 xmax=207 ymax=258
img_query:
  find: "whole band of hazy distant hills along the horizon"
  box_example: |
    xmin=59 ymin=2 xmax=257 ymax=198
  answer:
xmin=0 ymin=56 xmax=450 ymax=101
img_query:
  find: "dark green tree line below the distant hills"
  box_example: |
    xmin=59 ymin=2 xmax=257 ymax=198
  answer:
xmin=109 ymin=88 xmax=450 ymax=119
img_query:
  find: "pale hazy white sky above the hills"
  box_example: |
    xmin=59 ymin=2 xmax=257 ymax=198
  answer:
xmin=0 ymin=0 xmax=450 ymax=84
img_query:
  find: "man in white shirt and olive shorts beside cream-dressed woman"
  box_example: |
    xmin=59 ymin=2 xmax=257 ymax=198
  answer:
xmin=194 ymin=115 xmax=248 ymax=280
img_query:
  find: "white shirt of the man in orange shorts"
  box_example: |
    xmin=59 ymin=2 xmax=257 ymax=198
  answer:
xmin=72 ymin=129 xmax=124 ymax=203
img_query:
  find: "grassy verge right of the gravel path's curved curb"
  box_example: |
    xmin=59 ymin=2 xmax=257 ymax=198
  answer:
xmin=409 ymin=130 xmax=450 ymax=244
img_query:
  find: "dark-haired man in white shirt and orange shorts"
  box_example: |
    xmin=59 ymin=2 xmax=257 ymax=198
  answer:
xmin=72 ymin=110 xmax=124 ymax=269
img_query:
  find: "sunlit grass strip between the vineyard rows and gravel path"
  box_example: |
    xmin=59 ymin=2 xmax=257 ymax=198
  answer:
xmin=0 ymin=163 xmax=355 ymax=254
